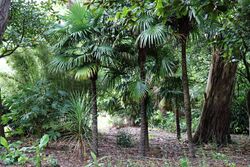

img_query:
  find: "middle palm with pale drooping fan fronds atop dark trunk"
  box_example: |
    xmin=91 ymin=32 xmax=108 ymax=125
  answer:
xmin=135 ymin=15 xmax=167 ymax=156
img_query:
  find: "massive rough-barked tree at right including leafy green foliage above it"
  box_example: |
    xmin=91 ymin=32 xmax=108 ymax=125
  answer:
xmin=193 ymin=1 xmax=249 ymax=145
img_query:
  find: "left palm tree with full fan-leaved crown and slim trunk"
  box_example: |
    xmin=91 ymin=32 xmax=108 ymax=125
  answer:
xmin=52 ymin=3 xmax=113 ymax=156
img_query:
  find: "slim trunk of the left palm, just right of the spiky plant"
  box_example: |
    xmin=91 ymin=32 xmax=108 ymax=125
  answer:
xmin=91 ymin=74 xmax=98 ymax=156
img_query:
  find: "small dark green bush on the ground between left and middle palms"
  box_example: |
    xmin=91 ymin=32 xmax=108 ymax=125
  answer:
xmin=116 ymin=131 xmax=133 ymax=148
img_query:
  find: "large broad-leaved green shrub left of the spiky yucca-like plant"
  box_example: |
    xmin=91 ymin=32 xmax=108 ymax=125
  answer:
xmin=2 ymin=81 xmax=69 ymax=135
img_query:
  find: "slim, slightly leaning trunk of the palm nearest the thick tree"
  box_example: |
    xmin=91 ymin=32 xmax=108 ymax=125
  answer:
xmin=181 ymin=34 xmax=195 ymax=157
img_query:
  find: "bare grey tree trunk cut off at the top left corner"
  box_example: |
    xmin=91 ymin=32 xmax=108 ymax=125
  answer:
xmin=0 ymin=0 xmax=10 ymax=43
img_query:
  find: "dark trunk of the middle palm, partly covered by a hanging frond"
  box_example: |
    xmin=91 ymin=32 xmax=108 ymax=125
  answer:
xmin=138 ymin=48 xmax=149 ymax=156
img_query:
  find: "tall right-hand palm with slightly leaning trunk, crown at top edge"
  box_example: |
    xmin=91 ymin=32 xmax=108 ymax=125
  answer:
xmin=156 ymin=1 xmax=199 ymax=157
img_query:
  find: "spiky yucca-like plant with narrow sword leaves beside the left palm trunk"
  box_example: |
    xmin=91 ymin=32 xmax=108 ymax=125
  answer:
xmin=65 ymin=92 xmax=91 ymax=162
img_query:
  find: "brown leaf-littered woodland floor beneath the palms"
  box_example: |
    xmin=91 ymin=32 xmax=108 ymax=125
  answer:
xmin=41 ymin=127 xmax=250 ymax=167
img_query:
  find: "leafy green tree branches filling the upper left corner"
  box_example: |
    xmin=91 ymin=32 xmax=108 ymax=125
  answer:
xmin=0 ymin=0 xmax=55 ymax=57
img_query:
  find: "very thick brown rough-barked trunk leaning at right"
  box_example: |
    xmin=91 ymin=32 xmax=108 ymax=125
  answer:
xmin=193 ymin=49 xmax=237 ymax=145
